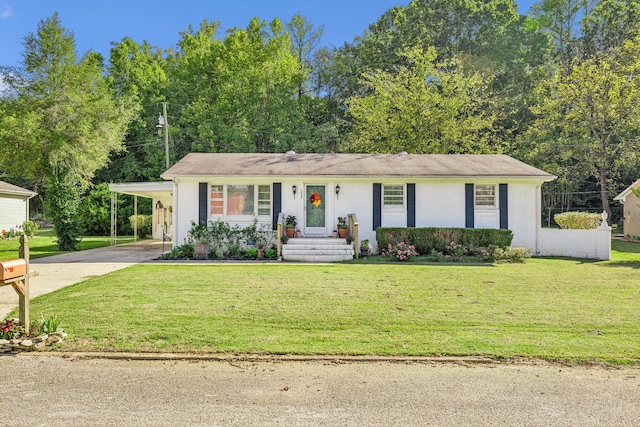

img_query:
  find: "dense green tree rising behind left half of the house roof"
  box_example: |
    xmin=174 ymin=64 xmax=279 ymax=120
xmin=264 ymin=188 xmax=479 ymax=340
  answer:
xmin=169 ymin=18 xmax=305 ymax=152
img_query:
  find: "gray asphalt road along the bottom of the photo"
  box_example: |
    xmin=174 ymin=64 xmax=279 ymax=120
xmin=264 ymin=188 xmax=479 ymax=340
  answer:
xmin=0 ymin=354 xmax=640 ymax=427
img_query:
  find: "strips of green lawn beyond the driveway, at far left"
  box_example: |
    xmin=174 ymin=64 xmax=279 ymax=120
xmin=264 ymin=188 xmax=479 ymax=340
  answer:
xmin=0 ymin=229 xmax=133 ymax=261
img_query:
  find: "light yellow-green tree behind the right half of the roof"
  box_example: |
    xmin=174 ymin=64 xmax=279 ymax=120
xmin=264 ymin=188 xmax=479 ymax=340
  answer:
xmin=347 ymin=48 xmax=500 ymax=154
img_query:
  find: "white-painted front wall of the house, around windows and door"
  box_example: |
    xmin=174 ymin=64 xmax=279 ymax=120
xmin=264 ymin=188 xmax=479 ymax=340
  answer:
xmin=174 ymin=177 xmax=540 ymax=253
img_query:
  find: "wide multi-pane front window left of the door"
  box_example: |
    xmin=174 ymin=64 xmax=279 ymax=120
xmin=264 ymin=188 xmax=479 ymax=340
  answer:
xmin=210 ymin=184 xmax=271 ymax=217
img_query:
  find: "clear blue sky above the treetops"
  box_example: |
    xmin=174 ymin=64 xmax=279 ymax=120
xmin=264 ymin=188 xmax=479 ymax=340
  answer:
xmin=0 ymin=0 xmax=534 ymax=66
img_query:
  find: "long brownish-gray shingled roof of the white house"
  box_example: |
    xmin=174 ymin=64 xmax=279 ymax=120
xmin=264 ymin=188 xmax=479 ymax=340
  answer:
xmin=162 ymin=153 xmax=555 ymax=181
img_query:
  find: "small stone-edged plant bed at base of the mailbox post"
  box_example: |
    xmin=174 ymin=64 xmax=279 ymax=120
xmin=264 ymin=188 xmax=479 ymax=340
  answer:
xmin=0 ymin=315 xmax=67 ymax=353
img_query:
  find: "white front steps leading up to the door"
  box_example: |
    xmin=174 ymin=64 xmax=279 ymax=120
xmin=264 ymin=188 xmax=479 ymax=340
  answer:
xmin=282 ymin=237 xmax=355 ymax=262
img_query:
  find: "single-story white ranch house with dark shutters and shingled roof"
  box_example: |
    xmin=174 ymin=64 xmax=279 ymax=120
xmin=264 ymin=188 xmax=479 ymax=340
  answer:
xmin=162 ymin=152 xmax=555 ymax=254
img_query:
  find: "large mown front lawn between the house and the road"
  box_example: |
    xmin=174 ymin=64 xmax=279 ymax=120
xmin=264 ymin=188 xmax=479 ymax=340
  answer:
xmin=25 ymin=242 xmax=640 ymax=364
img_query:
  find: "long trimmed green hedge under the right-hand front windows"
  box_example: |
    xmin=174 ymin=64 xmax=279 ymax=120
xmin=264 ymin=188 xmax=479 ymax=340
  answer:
xmin=376 ymin=227 xmax=513 ymax=255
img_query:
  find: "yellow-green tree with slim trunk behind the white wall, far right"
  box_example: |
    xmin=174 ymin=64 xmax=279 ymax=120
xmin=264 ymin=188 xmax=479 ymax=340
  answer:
xmin=531 ymin=38 xmax=640 ymax=218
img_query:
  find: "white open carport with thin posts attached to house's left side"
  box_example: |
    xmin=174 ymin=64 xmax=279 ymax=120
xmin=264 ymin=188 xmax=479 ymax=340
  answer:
xmin=109 ymin=181 xmax=173 ymax=245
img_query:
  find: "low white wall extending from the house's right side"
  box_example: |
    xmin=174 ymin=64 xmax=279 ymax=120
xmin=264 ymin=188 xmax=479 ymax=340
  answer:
xmin=538 ymin=213 xmax=611 ymax=260
